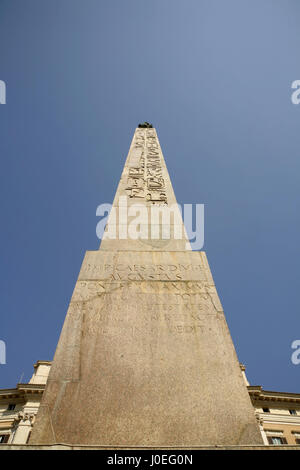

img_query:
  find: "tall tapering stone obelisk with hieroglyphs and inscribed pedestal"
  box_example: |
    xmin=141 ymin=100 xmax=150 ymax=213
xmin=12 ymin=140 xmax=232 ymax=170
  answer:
xmin=30 ymin=123 xmax=262 ymax=448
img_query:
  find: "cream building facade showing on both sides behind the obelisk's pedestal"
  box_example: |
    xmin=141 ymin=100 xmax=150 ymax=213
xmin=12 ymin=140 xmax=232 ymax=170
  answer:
xmin=0 ymin=361 xmax=300 ymax=445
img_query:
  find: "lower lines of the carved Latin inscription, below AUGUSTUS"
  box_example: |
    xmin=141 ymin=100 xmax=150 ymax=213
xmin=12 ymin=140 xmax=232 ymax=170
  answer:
xmin=70 ymin=281 xmax=220 ymax=336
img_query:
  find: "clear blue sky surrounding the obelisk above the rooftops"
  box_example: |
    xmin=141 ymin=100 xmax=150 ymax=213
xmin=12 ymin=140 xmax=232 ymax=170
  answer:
xmin=0 ymin=0 xmax=300 ymax=392
